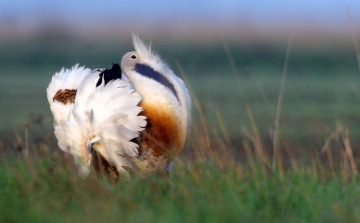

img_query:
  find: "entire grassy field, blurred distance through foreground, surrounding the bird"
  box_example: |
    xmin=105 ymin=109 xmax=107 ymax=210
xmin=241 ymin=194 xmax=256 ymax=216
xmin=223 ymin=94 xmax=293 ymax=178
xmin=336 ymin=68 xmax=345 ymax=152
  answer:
xmin=0 ymin=36 xmax=360 ymax=222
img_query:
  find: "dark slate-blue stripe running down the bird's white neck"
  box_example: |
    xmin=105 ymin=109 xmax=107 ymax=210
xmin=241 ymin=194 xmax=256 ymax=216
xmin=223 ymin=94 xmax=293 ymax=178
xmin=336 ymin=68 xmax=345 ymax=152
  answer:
xmin=135 ymin=63 xmax=180 ymax=102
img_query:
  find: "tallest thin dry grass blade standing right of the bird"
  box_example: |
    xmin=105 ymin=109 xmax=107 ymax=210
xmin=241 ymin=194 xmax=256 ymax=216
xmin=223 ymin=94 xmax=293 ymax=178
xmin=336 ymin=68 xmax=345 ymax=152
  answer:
xmin=272 ymin=33 xmax=293 ymax=174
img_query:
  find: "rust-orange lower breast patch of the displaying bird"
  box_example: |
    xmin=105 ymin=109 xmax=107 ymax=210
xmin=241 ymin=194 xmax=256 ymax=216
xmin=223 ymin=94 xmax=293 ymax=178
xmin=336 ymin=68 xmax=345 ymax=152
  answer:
xmin=137 ymin=100 xmax=184 ymax=165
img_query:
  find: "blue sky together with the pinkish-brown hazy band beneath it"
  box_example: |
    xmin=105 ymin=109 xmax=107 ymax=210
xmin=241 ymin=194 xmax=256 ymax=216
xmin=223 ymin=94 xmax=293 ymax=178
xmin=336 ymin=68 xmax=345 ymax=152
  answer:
xmin=0 ymin=0 xmax=360 ymax=38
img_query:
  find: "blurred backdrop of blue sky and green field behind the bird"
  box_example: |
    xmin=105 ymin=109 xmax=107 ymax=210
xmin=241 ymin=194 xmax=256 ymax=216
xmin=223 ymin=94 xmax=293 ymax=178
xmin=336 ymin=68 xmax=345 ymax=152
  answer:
xmin=0 ymin=0 xmax=360 ymax=150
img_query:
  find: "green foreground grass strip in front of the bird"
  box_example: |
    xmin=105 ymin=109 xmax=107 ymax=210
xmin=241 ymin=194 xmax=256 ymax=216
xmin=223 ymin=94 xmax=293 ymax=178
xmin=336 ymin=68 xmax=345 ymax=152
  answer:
xmin=0 ymin=139 xmax=360 ymax=222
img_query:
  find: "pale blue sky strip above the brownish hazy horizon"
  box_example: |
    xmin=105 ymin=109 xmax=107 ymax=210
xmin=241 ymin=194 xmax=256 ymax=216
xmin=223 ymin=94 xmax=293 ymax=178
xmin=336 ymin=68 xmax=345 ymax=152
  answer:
xmin=0 ymin=0 xmax=360 ymax=33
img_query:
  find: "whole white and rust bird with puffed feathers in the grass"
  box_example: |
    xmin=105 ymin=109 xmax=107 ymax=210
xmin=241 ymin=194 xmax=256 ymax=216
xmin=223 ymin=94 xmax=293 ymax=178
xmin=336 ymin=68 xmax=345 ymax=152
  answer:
xmin=47 ymin=34 xmax=191 ymax=179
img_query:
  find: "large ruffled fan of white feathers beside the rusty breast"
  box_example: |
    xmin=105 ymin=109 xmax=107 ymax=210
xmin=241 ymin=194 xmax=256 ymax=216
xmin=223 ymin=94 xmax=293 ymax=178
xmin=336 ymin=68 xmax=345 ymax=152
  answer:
xmin=55 ymin=74 xmax=146 ymax=175
